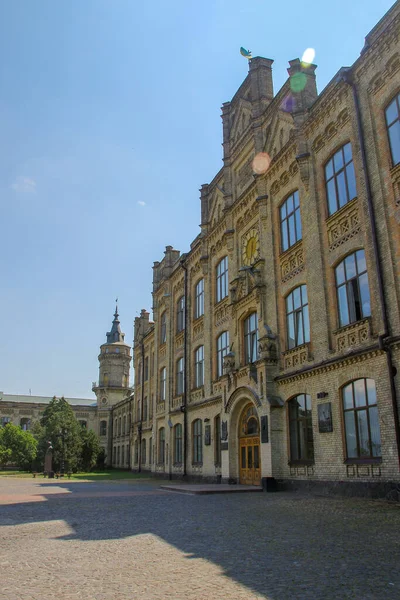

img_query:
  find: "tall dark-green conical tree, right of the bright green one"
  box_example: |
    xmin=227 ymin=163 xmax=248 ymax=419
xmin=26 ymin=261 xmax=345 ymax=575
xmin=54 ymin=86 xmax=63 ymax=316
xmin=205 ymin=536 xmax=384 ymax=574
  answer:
xmin=39 ymin=396 xmax=82 ymax=471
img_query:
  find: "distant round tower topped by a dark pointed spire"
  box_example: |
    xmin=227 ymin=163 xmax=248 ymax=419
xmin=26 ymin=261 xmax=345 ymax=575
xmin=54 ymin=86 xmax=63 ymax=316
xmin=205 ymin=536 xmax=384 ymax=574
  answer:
xmin=92 ymin=304 xmax=131 ymax=410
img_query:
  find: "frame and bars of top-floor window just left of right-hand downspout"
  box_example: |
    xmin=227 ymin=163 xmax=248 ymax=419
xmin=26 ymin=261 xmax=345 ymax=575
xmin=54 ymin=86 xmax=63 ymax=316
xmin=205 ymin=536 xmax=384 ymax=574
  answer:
xmin=324 ymin=140 xmax=357 ymax=217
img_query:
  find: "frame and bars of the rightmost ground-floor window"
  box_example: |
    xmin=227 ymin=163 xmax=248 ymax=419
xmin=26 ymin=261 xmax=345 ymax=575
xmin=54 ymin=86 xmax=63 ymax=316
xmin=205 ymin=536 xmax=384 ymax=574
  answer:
xmin=340 ymin=377 xmax=382 ymax=464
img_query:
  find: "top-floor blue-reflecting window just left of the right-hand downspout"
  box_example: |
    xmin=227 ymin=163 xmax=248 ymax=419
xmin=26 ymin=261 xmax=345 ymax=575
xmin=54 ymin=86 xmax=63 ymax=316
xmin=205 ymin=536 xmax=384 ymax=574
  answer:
xmin=325 ymin=142 xmax=357 ymax=215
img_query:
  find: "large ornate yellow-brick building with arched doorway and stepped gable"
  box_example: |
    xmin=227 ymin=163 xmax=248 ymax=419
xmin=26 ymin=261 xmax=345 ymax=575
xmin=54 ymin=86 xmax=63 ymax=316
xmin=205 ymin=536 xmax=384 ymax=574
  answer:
xmin=131 ymin=2 xmax=400 ymax=491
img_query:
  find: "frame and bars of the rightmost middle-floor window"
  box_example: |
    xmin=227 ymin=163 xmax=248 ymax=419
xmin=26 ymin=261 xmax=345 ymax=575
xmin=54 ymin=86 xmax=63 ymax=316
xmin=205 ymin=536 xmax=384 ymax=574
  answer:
xmin=334 ymin=248 xmax=371 ymax=328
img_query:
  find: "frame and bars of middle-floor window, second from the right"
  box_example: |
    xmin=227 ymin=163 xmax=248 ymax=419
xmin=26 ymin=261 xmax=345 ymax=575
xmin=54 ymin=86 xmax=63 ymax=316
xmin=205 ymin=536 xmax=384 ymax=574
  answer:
xmin=285 ymin=283 xmax=311 ymax=350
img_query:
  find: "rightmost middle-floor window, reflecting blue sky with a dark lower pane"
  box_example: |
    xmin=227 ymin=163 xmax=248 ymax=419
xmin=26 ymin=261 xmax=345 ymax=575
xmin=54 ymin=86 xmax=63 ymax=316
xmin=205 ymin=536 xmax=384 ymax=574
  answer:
xmin=335 ymin=250 xmax=371 ymax=327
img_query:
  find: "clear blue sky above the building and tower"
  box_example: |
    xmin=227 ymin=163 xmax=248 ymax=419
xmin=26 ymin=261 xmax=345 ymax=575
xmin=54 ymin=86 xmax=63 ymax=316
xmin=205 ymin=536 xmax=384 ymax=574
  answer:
xmin=0 ymin=0 xmax=392 ymax=397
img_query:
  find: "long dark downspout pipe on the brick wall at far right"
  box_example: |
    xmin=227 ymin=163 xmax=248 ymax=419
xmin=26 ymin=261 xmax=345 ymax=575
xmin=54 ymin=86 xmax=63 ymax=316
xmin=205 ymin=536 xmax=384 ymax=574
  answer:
xmin=342 ymin=68 xmax=400 ymax=467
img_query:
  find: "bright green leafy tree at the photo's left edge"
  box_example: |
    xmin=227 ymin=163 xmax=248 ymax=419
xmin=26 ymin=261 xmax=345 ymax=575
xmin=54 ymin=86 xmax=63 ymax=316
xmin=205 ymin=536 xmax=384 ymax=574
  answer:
xmin=0 ymin=423 xmax=38 ymax=469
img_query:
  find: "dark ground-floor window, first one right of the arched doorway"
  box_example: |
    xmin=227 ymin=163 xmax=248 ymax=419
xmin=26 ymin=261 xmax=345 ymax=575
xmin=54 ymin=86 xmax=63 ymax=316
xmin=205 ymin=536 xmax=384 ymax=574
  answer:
xmin=288 ymin=394 xmax=314 ymax=461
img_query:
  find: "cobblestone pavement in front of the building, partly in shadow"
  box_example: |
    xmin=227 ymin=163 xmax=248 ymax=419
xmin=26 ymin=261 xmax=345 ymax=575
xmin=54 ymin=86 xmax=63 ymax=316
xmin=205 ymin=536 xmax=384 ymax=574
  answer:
xmin=0 ymin=478 xmax=400 ymax=600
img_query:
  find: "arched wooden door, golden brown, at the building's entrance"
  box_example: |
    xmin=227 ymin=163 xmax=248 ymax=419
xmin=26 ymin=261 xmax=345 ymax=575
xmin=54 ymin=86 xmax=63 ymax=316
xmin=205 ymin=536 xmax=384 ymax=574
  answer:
xmin=239 ymin=403 xmax=261 ymax=485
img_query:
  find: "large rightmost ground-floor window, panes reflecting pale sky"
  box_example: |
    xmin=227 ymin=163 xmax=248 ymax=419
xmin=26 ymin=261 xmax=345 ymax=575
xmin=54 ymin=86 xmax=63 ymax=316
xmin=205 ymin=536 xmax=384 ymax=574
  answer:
xmin=342 ymin=379 xmax=382 ymax=458
